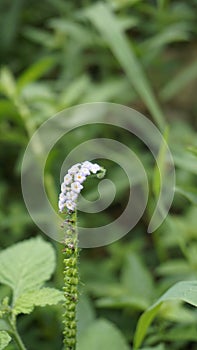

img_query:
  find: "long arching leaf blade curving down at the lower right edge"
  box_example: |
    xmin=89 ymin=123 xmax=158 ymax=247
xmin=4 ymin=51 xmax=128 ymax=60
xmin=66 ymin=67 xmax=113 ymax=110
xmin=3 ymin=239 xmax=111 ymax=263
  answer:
xmin=134 ymin=281 xmax=197 ymax=349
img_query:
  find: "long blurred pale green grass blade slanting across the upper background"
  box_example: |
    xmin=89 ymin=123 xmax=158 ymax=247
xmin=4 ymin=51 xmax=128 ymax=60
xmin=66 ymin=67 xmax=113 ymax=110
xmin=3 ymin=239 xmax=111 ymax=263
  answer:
xmin=85 ymin=3 xmax=165 ymax=128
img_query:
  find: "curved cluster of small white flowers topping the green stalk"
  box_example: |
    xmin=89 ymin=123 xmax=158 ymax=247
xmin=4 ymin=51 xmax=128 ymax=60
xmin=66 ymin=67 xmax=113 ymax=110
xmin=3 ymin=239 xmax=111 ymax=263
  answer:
xmin=58 ymin=161 xmax=101 ymax=213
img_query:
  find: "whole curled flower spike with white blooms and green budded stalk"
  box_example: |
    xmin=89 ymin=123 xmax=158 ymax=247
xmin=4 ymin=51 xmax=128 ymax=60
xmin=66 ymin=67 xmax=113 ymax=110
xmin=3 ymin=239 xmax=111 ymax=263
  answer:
xmin=59 ymin=161 xmax=105 ymax=350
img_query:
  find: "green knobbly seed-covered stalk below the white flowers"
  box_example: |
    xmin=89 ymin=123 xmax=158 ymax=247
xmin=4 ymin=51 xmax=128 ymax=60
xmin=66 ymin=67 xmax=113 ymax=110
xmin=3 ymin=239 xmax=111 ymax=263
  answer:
xmin=63 ymin=212 xmax=79 ymax=350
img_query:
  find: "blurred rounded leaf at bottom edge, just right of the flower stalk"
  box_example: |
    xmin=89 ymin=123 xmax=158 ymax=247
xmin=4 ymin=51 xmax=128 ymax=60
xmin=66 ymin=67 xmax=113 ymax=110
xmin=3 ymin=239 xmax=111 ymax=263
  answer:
xmin=77 ymin=320 xmax=130 ymax=350
